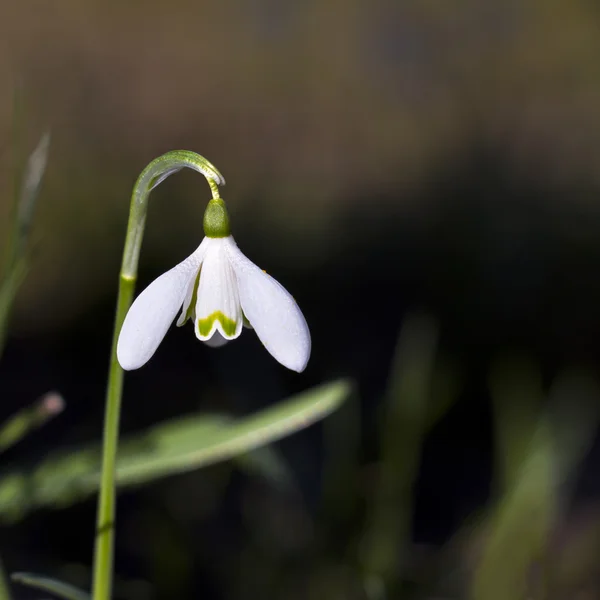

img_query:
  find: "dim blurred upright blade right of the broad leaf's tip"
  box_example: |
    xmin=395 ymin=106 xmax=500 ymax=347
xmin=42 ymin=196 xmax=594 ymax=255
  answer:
xmin=361 ymin=315 xmax=438 ymax=597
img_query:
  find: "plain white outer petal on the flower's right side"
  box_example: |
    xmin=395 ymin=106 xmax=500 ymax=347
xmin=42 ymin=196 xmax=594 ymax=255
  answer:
xmin=224 ymin=236 xmax=311 ymax=373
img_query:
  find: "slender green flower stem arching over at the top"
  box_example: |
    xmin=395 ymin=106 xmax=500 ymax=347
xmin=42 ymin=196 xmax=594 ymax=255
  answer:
xmin=92 ymin=150 xmax=225 ymax=600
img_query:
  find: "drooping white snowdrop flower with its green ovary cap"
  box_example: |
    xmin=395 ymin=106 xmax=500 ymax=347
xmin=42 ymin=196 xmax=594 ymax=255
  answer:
xmin=117 ymin=198 xmax=311 ymax=372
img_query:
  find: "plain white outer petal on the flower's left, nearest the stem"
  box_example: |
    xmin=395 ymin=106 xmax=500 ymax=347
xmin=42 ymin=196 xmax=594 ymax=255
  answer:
xmin=117 ymin=239 xmax=206 ymax=371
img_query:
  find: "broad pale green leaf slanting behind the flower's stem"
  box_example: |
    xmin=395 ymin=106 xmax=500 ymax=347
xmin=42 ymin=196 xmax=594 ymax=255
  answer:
xmin=0 ymin=380 xmax=352 ymax=521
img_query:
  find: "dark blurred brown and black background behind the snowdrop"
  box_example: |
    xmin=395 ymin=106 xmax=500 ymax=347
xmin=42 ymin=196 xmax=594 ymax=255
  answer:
xmin=0 ymin=0 xmax=600 ymax=600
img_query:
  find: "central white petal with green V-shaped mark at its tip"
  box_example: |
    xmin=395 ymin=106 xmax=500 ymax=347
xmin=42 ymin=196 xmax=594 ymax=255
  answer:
xmin=196 ymin=238 xmax=243 ymax=342
